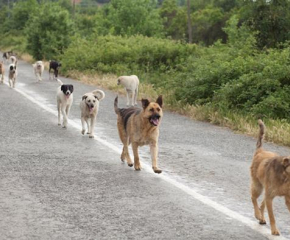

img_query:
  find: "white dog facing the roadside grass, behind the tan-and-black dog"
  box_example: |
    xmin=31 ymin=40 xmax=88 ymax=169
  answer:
xmin=117 ymin=75 xmax=139 ymax=106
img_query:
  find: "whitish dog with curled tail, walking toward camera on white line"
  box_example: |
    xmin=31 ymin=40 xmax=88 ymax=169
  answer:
xmin=80 ymin=89 xmax=105 ymax=138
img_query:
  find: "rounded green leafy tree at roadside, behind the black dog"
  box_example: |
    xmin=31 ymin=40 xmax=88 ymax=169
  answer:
xmin=25 ymin=3 xmax=73 ymax=60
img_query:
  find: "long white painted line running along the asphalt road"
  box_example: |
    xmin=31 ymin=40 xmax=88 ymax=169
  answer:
xmin=5 ymin=82 xmax=287 ymax=240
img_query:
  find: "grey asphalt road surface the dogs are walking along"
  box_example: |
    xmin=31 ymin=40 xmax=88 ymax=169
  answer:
xmin=0 ymin=57 xmax=290 ymax=239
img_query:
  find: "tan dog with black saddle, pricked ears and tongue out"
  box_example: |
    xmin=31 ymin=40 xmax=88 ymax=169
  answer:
xmin=114 ymin=96 xmax=163 ymax=173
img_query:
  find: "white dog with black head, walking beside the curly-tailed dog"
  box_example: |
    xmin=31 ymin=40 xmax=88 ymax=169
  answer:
xmin=56 ymin=79 xmax=74 ymax=128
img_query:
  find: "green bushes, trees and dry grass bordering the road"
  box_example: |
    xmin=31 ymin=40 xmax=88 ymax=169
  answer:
xmin=0 ymin=0 xmax=290 ymax=146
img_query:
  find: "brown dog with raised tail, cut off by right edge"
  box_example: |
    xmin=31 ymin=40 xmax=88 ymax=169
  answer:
xmin=251 ymin=120 xmax=290 ymax=235
